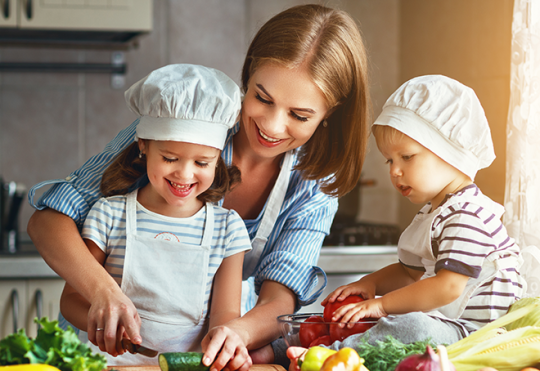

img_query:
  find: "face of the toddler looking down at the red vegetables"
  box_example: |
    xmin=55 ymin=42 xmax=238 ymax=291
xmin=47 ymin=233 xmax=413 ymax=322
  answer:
xmin=377 ymin=135 xmax=472 ymax=210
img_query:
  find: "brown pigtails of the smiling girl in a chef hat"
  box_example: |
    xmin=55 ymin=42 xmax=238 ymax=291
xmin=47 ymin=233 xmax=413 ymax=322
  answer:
xmin=100 ymin=142 xmax=241 ymax=202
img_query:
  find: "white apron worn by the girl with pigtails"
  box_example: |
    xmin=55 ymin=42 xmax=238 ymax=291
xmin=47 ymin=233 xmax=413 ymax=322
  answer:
xmin=94 ymin=191 xmax=214 ymax=366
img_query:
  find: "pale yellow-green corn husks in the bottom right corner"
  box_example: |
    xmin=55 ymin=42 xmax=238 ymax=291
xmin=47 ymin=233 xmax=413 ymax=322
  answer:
xmin=447 ymin=302 xmax=540 ymax=371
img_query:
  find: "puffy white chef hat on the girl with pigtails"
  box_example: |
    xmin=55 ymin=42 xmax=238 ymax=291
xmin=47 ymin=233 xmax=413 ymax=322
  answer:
xmin=124 ymin=64 xmax=241 ymax=150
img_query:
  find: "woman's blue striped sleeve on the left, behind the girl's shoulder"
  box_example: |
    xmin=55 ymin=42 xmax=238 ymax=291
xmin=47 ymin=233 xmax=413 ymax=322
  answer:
xmin=28 ymin=119 xmax=139 ymax=227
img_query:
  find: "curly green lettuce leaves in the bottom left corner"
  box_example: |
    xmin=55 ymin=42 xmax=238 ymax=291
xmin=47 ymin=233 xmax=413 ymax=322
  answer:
xmin=0 ymin=318 xmax=107 ymax=371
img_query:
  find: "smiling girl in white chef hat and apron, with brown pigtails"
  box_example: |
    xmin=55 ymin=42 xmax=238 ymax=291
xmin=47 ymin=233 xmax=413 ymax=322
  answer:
xmin=61 ymin=64 xmax=251 ymax=365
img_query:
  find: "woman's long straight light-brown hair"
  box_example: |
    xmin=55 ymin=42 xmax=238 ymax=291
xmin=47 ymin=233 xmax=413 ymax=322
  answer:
xmin=242 ymin=4 xmax=371 ymax=196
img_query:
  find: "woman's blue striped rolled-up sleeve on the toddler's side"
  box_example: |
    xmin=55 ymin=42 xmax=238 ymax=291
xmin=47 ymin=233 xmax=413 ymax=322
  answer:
xmin=255 ymin=187 xmax=338 ymax=306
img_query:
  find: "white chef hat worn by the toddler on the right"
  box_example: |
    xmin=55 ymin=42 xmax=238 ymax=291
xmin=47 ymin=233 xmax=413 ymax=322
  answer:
xmin=373 ymin=75 xmax=495 ymax=180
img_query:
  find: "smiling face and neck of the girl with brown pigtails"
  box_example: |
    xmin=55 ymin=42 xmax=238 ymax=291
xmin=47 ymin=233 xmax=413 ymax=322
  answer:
xmin=139 ymin=140 xmax=220 ymax=217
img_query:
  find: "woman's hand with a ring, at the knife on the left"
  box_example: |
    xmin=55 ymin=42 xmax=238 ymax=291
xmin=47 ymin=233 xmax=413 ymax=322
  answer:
xmin=87 ymin=290 xmax=142 ymax=356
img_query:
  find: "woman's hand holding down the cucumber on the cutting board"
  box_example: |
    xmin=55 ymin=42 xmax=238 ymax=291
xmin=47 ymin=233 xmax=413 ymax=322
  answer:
xmin=201 ymin=326 xmax=253 ymax=371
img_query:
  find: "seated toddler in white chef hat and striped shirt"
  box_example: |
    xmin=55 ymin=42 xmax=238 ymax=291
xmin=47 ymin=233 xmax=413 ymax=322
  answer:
xmin=289 ymin=76 xmax=526 ymax=366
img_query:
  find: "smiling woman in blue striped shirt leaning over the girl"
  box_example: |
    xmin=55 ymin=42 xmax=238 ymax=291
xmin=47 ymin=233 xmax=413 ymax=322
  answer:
xmin=28 ymin=5 xmax=370 ymax=371
